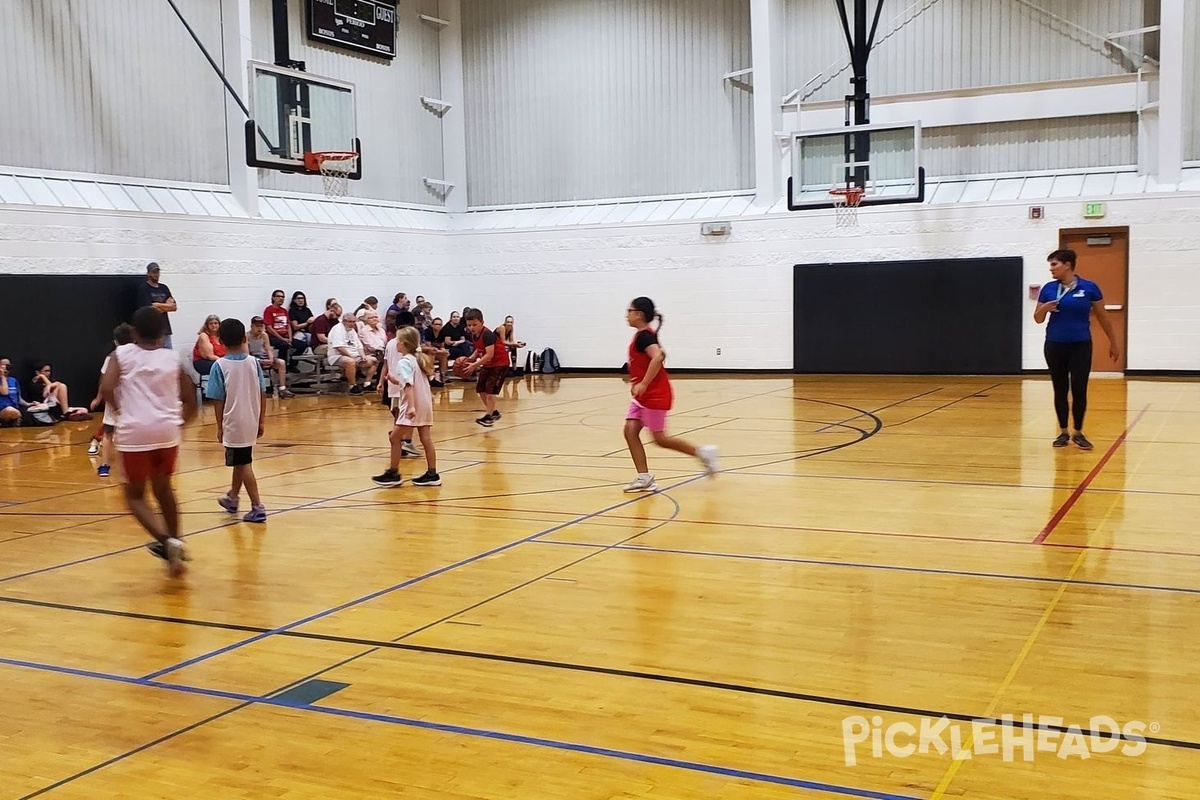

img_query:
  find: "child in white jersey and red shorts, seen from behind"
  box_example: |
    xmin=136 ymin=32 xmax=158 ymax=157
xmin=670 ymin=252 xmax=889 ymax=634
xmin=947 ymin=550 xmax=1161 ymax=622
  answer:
xmin=100 ymin=306 xmax=196 ymax=577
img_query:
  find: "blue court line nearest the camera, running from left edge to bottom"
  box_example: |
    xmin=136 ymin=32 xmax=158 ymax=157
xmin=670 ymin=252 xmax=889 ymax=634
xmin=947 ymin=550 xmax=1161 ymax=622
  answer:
xmin=0 ymin=657 xmax=918 ymax=800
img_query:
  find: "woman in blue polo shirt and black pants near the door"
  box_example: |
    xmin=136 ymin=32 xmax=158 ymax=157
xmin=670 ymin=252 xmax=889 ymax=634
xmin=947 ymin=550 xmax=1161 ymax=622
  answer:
xmin=1033 ymin=249 xmax=1121 ymax=450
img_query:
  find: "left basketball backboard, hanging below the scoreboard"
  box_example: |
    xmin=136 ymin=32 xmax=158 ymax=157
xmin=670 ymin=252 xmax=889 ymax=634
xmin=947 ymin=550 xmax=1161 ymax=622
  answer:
xmin=246 ymin=61 xmax=362 ymax=180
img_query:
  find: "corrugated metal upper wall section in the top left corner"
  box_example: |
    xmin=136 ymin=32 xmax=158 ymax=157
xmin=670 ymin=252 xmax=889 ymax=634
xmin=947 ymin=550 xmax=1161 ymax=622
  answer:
xmin=0 ymin=0 xmax=229 ymax=184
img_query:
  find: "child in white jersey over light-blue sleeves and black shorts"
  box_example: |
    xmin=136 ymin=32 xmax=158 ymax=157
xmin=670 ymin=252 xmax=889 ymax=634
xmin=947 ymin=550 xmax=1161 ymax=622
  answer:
xmin=205 ymin=319 xmax=266 ymax=522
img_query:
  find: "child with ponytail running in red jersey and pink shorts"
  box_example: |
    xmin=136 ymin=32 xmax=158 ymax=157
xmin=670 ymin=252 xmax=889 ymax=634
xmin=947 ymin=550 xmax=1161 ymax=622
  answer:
xmin=625 ymin=297 xmax=719 ymax=492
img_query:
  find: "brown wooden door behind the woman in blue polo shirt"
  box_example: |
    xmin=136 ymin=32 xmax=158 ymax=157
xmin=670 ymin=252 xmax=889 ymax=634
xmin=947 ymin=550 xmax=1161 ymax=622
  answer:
xmin=1058 ymin=228 xmax=1129 ymax=372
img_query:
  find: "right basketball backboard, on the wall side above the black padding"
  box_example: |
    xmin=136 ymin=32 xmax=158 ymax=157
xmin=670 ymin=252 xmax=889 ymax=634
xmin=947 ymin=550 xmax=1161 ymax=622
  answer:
xmin=787 ymin=122 xmax=925 ymax=211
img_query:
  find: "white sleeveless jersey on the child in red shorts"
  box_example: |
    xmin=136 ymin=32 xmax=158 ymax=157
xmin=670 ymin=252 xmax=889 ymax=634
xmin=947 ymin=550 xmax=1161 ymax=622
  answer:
xmin=112 ymin=344 xmax=184 ymax=452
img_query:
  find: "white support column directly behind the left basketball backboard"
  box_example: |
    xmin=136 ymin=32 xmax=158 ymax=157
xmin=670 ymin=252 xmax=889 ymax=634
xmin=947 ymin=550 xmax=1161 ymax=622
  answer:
xmin=221 ymin=0 xmax=258 ymax=217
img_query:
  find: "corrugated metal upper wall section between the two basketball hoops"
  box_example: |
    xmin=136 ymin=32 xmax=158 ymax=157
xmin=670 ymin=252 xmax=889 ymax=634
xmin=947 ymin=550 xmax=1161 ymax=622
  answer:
xmin=462 ymin=0 xmax=754 ymax=206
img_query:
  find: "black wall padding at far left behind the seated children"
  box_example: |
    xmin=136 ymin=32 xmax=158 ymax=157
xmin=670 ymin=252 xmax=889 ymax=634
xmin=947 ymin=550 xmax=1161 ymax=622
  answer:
xmin=0 ymin=275 xmax=144 ymax=407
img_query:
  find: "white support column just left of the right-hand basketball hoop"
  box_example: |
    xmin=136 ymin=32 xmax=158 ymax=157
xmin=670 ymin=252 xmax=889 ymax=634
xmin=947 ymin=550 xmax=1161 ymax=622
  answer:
xmin=750 ymin=0 xmax=784 ymax=207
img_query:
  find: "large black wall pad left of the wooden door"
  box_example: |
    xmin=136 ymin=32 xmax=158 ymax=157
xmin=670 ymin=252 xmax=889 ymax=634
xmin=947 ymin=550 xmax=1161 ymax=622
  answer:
xmin=793 ymin=258 xmax=1026 ymax=374
